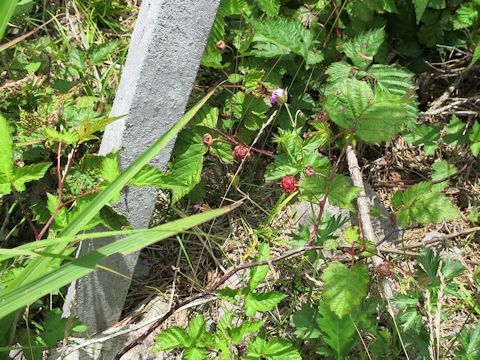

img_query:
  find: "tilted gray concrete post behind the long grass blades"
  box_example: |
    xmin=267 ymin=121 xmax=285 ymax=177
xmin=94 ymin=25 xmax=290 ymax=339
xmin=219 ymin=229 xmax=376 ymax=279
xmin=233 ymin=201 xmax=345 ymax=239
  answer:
xmin=64 ymin=0 xmax=220 ymax=334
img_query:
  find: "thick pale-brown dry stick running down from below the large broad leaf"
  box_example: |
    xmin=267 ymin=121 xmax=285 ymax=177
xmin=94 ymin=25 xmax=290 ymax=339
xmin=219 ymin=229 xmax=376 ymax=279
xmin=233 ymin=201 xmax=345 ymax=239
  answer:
xmin=346 ymin=144 xmax=398 ymax=318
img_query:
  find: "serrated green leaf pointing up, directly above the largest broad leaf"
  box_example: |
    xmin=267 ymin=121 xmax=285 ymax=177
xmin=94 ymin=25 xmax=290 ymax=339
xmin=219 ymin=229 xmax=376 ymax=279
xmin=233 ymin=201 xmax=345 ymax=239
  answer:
xmin=343 ymin=28 xmax=385 ymax=68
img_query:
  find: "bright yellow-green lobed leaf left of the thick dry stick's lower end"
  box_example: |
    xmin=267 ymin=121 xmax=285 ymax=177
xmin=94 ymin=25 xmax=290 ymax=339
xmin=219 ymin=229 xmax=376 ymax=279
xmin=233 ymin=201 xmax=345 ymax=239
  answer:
xmin=322 ymin=263 xmax=369 ymax=318
